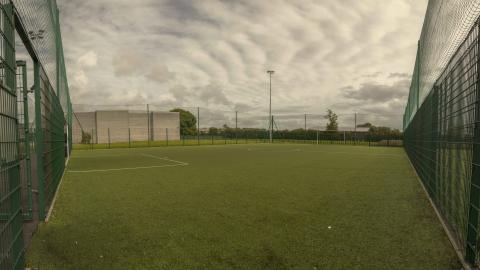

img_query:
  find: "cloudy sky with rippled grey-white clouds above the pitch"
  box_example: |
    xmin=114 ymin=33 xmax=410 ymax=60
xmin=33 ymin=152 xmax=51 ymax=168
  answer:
xmin=58 ymin=0 xmax=427 ymax=130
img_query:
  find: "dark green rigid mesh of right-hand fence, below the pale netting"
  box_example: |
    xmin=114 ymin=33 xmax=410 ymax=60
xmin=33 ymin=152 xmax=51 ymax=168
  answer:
xmin=404 ymin=16 xmax=480 ymax=266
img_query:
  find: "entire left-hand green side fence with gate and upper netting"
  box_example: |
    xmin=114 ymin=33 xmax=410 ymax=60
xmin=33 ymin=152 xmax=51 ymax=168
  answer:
xmin=0 ymin=0 xmax=72 ymax=270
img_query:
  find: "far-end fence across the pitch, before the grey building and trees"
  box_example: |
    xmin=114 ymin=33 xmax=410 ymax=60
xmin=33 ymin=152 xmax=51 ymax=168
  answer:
xmin=72 ymin=104 xmax=402 ymax=149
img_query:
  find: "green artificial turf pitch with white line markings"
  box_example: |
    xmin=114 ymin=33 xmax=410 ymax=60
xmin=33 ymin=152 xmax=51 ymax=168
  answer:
xmin=27 ymin=144 xmax=460 ymax=269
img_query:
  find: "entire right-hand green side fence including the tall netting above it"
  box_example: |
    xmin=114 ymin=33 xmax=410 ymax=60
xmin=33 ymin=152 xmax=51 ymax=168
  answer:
xmin=404 ymin=1 xmax=480 ymax=267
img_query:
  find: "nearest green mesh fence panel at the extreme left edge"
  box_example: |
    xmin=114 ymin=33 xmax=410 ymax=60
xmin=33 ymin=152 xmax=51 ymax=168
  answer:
xmin=0 ymin=0 xmax=24 ymax=269
